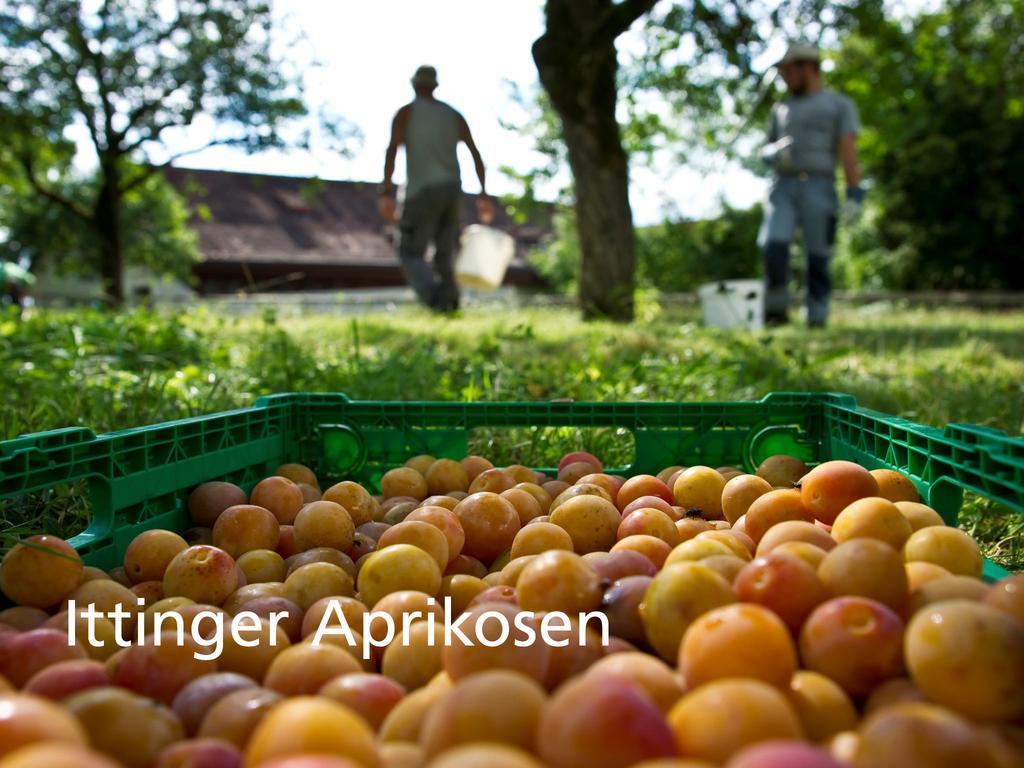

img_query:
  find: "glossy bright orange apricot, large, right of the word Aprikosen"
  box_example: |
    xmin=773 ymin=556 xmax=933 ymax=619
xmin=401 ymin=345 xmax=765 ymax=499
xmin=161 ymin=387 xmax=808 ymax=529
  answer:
xmin=679 ymin=603 xmax=797 ymax=690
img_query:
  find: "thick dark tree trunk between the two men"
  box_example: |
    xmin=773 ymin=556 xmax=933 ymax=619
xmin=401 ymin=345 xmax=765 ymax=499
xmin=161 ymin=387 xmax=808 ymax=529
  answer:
xmin=534 ymin=0 xmax=653 ymax=322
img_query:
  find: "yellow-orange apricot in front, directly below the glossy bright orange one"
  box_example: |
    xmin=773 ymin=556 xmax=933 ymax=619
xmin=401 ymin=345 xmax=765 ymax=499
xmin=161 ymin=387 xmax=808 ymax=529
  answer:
xmin=669 ymin=678 xmax=804 ymax=764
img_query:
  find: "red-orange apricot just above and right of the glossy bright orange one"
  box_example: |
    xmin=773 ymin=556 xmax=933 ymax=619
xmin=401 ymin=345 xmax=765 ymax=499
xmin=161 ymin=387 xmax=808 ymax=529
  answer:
xmin=732 ymin=552 xmax=828 ymax=633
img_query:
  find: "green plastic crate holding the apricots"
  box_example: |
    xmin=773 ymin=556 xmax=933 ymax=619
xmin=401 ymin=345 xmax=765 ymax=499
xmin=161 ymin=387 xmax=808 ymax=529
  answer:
xmin=0 ymin=392 xmax=1024 ymax=579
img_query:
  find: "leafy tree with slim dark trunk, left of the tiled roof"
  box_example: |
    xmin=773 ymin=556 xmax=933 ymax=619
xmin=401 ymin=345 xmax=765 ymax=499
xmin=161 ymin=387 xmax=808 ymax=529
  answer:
xmin=0 ymin=0 xmax=337 ymax=305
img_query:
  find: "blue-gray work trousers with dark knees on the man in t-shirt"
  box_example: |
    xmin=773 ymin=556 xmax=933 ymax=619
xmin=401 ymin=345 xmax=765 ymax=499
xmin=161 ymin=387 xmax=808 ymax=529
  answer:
xmin=760 ymin=176 xmax=839 ymax=324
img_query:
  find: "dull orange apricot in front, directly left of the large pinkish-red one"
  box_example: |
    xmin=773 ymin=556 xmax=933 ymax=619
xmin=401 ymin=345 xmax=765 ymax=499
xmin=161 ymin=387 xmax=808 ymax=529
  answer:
xmin=420 ymin=670 xmax=546 ymax=758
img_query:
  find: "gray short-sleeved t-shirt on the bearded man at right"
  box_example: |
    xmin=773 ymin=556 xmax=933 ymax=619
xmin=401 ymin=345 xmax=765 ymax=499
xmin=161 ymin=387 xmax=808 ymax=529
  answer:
xmin=768 ymin=89 xmax=860 ymax=175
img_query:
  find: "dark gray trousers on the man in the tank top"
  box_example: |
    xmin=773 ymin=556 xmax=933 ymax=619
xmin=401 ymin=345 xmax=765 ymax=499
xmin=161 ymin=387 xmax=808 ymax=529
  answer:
xmin=398 ymin=181 xmax=462 ymax=311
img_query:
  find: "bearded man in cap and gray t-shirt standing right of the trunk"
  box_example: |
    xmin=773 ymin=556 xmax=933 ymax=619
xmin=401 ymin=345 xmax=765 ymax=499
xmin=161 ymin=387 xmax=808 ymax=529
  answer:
xmin=761 ymin=44 xmax=864 ymax=328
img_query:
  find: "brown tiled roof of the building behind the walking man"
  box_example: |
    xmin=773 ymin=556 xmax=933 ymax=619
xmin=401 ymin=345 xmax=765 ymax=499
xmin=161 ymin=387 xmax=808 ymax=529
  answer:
xmin=165 ymin=168 xmax=550 ymax=266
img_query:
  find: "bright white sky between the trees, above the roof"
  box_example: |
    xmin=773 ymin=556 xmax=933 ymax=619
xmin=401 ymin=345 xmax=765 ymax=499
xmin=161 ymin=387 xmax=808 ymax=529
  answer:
xmin=79 ymin=0 xmax=794 ymax=224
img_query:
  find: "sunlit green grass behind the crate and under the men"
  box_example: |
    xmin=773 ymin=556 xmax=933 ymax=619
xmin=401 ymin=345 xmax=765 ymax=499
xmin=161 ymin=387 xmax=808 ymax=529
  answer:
xmin=0 ymin=303 xmax=1024 ymax=569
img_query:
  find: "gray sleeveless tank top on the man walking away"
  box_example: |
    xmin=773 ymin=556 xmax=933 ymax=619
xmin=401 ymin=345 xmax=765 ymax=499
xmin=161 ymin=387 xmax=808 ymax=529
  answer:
xmin=406 ymin=98 xmax=462 ymax=198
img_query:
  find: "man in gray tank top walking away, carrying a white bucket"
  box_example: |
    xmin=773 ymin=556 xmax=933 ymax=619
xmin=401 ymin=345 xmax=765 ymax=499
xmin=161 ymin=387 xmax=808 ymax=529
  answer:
xmin=378 ymin=67 xmax=494 ymax=312
